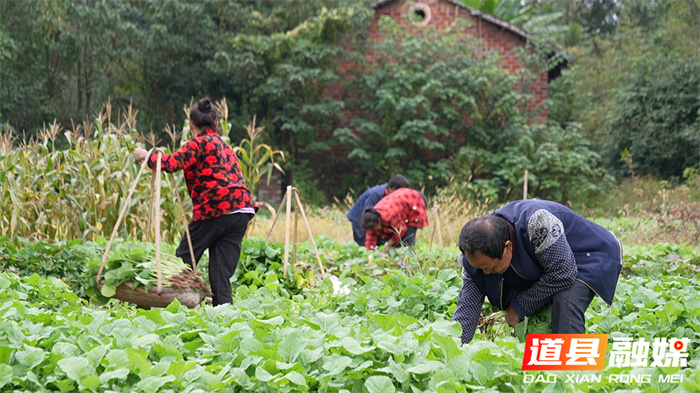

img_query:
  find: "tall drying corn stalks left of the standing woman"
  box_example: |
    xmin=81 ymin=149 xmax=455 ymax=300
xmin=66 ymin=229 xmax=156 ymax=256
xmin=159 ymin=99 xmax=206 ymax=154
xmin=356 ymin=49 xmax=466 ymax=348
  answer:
xmin=0 ymin=101 xmax=182 ymax=241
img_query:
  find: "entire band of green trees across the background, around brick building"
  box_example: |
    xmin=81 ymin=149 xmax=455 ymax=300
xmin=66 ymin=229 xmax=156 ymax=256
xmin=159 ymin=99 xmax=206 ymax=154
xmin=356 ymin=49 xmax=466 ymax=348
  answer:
xmin=0 ymin=0 xmax=700 ymax=202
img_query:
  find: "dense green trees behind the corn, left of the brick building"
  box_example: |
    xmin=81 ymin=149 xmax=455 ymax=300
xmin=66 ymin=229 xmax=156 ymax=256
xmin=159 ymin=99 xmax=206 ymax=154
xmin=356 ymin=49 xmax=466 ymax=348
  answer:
xmin=0 ymin=0 xmax=378 ymax=202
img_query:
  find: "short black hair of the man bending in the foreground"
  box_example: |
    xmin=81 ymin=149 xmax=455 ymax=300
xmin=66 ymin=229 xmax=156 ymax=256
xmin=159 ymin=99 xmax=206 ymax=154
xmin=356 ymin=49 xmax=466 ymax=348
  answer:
xmin=459 ymin=215 xmax=511 ymax=259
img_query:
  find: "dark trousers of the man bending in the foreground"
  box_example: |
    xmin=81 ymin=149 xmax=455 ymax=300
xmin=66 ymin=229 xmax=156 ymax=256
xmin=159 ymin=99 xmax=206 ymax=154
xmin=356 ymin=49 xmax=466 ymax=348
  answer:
xmin=552 ymin=280 xmax=595 ymax=334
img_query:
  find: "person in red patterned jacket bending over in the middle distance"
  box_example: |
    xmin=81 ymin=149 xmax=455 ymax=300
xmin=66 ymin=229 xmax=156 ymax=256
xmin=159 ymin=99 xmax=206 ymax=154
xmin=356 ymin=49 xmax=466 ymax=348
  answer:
xmin=362 ymin=188 xmax=428 ymax=252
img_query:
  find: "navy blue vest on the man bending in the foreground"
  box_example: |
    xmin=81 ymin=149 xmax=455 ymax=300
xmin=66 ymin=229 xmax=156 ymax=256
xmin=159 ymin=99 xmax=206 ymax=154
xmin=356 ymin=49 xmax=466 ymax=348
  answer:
xmin=461 ymin=200 xmax=622 ymax=316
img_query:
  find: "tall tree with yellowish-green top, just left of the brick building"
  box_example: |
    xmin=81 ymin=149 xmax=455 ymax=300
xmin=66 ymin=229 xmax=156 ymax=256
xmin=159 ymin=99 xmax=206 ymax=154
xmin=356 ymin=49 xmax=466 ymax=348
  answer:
xmin=208 ymin=0 xmax=372 ymax=200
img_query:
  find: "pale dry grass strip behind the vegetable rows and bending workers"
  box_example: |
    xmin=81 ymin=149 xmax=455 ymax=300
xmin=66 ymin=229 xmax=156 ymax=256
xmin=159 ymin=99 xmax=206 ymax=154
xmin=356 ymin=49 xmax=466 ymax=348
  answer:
xmin=248 ymin=176 xmax=700 ymax=249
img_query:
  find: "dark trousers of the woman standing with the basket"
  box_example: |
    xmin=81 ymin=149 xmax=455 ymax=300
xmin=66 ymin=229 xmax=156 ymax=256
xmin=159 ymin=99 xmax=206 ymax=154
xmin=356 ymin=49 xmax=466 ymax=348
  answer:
xmin=176 ymin=213 xmax=253 ymax=306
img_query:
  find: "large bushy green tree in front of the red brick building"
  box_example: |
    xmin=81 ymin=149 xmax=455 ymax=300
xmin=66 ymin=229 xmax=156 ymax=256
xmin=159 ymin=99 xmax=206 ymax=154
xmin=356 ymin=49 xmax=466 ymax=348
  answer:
xmin=334 ymin=18 xmax=531 ymax=198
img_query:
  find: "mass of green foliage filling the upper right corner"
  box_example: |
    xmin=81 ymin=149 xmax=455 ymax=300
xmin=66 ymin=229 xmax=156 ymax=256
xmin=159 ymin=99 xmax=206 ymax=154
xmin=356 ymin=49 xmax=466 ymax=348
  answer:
xmin=550 ymin=0 xmax=700 ymax=180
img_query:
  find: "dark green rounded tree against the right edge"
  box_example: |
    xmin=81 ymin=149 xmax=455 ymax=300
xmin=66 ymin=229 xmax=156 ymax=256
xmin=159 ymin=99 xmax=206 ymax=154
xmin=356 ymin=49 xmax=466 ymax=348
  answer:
xmin=609 ymin=51 xmax=700 ymax=179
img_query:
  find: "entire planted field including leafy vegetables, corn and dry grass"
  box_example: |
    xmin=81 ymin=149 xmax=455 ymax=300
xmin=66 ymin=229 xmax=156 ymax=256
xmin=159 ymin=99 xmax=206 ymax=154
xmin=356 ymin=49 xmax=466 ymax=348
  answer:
xmin=0 ymin=85 xmax=700 ymax=393
